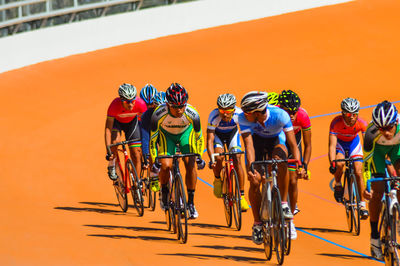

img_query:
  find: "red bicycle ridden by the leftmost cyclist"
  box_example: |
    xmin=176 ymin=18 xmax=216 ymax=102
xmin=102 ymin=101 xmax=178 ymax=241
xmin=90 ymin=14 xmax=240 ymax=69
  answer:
xmin=107 ymin=141 xmax=144 ymax=216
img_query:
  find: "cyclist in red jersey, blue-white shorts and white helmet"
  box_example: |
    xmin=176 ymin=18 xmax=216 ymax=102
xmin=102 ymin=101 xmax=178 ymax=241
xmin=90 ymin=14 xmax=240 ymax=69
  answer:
xmin=328 ymin=98 xmax=369 ymax=219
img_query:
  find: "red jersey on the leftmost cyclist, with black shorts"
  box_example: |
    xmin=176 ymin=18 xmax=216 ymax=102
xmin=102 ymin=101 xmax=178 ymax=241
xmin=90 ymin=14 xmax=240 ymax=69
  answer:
xmin=107 ymin=97 xmax=147 ymax=123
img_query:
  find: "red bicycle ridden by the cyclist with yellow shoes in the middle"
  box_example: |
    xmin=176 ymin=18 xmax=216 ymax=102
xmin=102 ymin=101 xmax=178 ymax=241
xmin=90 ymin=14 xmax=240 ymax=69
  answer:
xmin=211 ymin=148 xmax=244 ymax=231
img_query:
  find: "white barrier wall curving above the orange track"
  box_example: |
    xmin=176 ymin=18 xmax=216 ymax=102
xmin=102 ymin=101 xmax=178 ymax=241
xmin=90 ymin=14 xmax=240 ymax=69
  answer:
xmin=0 ymin=0 xmax=352 ymax=73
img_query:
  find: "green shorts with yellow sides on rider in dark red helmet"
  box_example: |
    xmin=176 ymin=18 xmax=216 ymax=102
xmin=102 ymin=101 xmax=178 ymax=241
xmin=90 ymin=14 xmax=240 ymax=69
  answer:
xmin=158 ymin=124 xmax=196 ymax=156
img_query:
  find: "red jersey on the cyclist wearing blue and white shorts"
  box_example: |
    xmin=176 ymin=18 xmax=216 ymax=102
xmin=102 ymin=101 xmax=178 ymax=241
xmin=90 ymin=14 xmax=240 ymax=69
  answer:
xmin=329 ymin=115 xmax=367 ymax=141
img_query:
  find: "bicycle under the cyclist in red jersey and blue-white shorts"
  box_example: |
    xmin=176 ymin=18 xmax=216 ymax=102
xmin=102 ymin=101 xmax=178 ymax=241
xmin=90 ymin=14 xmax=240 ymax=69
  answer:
xmin=332 ymin=151 xmax=361 ymax=236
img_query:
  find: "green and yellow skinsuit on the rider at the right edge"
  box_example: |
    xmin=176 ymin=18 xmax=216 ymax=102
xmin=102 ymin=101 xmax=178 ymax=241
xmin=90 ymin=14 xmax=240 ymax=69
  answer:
xmin=363 ymin=117 xmax=400 ymax=182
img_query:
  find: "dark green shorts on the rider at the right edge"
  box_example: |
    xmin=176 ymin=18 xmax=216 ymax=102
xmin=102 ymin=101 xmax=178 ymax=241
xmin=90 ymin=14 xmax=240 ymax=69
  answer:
xmin=371 ymin=143 xmax=400 ymax=174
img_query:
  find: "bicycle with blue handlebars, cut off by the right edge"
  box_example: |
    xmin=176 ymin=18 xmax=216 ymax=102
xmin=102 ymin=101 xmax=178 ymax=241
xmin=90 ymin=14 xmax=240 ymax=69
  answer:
xmin=367 ymin=171 xmax=400 ymax=265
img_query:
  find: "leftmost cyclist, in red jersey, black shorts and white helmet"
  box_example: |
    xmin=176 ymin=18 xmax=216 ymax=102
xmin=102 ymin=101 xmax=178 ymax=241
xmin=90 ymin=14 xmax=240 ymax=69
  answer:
xmin=104 ymin=83 xmax=146 ymax=180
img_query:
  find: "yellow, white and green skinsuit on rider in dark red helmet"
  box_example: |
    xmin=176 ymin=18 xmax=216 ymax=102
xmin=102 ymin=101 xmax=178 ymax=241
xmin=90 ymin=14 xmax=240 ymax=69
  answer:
xmin=150 ymin=104 xmax=204 ymax=161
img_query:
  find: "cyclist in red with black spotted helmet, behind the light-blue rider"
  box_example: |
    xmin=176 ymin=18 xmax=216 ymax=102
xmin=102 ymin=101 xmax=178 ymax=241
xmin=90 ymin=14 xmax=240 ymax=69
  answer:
xmin=279 ymin=90 xmax=311 ymax=239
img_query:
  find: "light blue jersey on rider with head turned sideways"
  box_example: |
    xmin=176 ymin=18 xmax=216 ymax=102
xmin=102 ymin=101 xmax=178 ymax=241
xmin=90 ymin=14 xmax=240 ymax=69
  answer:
xmin=239 ymin=105 xmax=293 ymax=143
